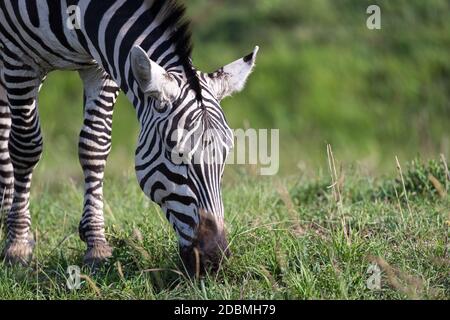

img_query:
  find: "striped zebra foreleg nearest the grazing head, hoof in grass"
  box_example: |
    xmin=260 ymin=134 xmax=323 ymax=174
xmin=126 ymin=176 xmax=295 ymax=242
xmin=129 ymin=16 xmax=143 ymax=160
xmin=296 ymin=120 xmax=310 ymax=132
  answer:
xmin=78 ymin=68 xmax=119 ymax=266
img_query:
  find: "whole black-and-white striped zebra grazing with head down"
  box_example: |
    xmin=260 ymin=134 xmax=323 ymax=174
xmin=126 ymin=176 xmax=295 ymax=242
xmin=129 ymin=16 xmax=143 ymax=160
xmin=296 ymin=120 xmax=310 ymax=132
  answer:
xmin=0 ymin=0 xmax=259 ymax=274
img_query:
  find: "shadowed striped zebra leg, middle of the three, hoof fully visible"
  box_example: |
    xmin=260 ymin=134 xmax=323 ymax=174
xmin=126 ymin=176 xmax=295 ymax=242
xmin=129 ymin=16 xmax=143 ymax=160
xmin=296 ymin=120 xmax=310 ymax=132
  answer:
xmin=3 ymin=66 xmax=43 ymax=265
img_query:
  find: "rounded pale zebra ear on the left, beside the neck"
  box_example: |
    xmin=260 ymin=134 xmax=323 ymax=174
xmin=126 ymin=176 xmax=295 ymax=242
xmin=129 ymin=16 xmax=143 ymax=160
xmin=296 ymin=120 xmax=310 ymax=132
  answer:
xmin=130 ymin=46 xmax=179 ymax=101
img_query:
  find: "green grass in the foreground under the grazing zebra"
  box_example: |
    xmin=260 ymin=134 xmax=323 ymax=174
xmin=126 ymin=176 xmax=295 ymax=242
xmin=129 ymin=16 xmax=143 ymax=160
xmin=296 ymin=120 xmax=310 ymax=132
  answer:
xmin=0 ymin=162 xmax=450 ymax=299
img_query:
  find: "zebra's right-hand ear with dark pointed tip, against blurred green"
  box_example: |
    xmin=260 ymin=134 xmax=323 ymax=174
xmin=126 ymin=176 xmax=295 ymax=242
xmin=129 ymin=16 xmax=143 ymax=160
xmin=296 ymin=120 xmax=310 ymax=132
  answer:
xmin=209 ymin=46 xmax=259 ymax=100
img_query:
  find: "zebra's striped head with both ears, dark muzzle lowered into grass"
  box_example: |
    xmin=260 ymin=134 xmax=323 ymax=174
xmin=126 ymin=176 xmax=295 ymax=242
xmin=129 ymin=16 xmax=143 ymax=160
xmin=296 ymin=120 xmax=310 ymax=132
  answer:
xmin=130 ymin=47 xmax=258 ymax=274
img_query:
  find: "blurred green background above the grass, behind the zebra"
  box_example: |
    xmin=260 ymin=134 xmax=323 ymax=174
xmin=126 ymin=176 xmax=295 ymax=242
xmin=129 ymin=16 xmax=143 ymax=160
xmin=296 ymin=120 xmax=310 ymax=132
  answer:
xmin=37 ymin=0 xmax=450 ymax=183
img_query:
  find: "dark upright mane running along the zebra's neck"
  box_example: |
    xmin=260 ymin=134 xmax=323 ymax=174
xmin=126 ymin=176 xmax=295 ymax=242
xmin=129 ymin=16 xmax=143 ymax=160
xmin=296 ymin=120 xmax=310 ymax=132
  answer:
xmin=145 ymin=0 xmax=202 ymax=101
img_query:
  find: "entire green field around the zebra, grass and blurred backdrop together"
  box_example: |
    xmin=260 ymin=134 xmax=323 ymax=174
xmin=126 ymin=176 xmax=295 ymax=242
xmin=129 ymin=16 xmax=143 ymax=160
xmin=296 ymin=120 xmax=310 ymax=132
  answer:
xmin=0 ymin=0 xmax=450 ymax=300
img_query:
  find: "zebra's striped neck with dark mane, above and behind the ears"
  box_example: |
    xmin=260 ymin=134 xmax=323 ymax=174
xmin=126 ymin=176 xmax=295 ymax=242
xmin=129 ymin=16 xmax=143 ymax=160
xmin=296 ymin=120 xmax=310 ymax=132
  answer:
xmin=80 ymin=0 xmax=195 ymax=107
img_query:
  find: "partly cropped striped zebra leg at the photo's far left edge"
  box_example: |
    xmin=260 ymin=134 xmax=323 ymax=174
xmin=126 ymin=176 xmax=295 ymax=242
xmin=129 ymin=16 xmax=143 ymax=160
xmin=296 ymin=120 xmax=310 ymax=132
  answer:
xmin=0 ymin=76 xmax=14 ymax=225
